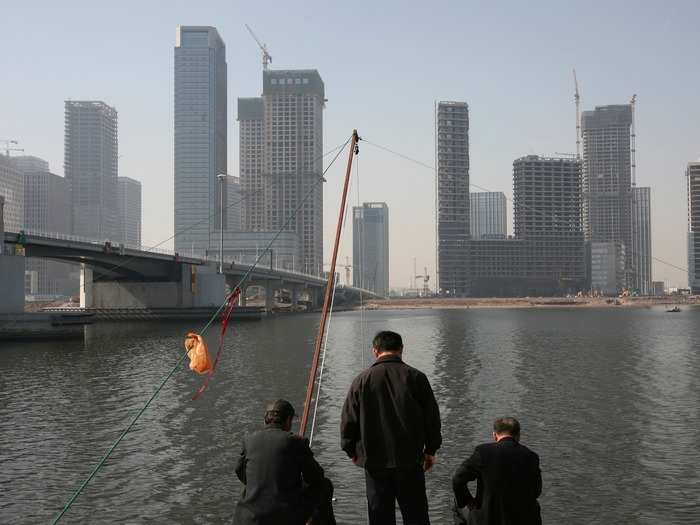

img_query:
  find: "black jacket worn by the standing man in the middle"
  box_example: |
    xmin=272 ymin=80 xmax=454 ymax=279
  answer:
xmin=340 ymin=356 xmax=442 ymax=469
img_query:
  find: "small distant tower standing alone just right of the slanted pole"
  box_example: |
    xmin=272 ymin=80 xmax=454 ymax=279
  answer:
xmin=352 ymin=202 xmax=389 ymax=296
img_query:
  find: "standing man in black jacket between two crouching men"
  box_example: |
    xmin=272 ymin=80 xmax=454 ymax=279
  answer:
xmin=340 ymin=332 xmax=442 ymax=525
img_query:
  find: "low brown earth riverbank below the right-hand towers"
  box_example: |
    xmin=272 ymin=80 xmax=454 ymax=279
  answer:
xmin=365 ymin=296 xmax=700 ymax=310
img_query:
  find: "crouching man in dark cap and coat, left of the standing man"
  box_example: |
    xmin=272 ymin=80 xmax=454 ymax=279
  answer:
xmin=234 ymin=399 xmax=335 ymax=525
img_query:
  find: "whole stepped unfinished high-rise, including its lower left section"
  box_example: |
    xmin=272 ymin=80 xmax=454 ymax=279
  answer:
xmin=238 ymin=69 xmax=325 ymax=275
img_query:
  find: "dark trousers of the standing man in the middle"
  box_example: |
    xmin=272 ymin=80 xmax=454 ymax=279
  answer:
xmin=365 ymin=465 xmax=430 ymax=525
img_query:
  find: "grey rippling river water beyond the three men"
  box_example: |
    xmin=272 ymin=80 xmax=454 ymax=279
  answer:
xmin=0 ymin=309 xmax=700 ymax=524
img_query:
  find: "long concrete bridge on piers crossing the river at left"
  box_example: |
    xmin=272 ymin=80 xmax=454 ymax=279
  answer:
xmin=0 ymin=230 xmax=377 ymax=310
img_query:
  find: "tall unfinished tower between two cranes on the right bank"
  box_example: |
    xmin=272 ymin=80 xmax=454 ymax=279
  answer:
xmin=581 ymin=104 xmax=633 ymax=289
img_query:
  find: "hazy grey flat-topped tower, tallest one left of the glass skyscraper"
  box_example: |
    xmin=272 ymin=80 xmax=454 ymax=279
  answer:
xmin=64 ymin=100 xmax=118 ymax=241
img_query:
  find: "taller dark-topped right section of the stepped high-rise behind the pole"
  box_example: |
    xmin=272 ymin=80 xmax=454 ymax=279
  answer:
xmin=262 ymin=69 xmax=326 ymax=275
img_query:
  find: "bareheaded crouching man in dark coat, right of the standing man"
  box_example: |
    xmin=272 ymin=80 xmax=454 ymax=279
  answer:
xmin=452 ymin=417 xmax=542 ymax=525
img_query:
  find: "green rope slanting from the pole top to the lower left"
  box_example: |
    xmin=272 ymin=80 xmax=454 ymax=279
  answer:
xmin=51 ymin=137 xmax=352 ymax=525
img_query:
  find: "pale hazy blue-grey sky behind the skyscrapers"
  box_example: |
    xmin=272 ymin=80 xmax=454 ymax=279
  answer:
xmin=0 ymin=0 xmax=700 ymax=286
